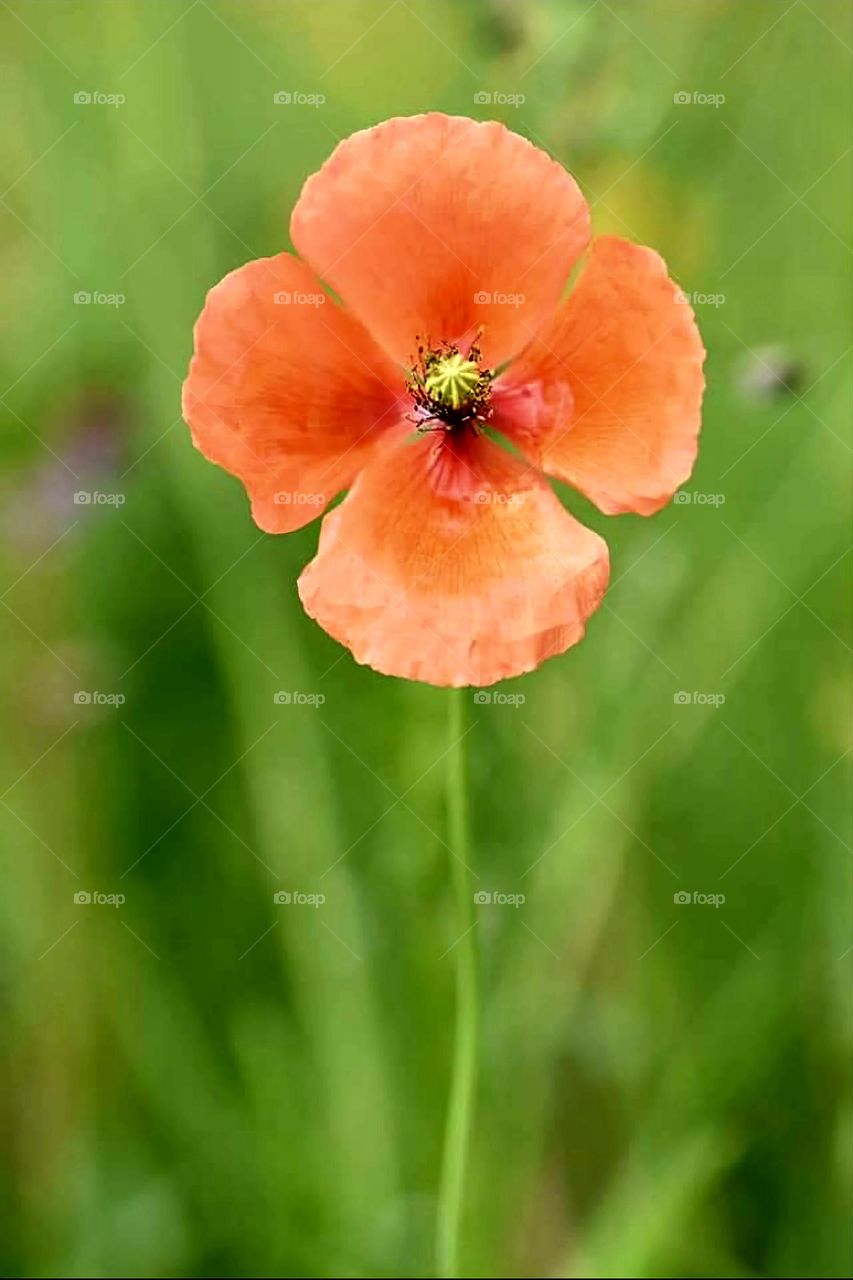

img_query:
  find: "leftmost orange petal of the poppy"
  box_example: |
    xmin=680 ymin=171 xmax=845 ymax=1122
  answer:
xmin=183 ymin=253 xmax=403 ymax=534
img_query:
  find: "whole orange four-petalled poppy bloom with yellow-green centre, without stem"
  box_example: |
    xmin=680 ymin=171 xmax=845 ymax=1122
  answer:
xmin=183 ymin=114 xmax=704 ymax=685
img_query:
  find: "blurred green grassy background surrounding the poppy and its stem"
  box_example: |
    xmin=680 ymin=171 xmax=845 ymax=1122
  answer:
xmin=0 ymin=0 xmax=853 ymax=1277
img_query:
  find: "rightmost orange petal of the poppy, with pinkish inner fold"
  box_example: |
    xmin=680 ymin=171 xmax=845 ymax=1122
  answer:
xmin=493 ymin=236 xmax=704 ymax=516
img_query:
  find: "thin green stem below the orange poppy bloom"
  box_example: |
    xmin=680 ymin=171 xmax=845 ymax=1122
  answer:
xmin=435 ymin=689 xmax=478 ymax=1280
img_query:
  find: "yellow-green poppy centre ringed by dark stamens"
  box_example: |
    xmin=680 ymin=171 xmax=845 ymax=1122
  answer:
xmin=406 ymin=339 xmax=493 ymax=431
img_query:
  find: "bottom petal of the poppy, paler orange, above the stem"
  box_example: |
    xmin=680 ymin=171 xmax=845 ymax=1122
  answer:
xmin=298 ymin=434 xmax=608 ymax=686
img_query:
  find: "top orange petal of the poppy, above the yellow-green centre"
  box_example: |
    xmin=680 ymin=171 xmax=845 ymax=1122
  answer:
xmin=291 ymin=113 xmax=589 ymax=367
